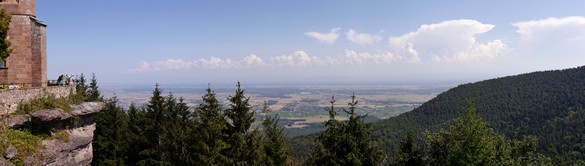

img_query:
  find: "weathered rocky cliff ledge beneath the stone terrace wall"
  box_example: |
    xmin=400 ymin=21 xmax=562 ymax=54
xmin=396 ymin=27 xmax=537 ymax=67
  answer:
xmin=0 ymin=102 xmax=104 ymax=165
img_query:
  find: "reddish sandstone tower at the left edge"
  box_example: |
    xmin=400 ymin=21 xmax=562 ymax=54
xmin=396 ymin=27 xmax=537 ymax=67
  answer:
xmin=0 ymin=0 xmax=47 ymax=87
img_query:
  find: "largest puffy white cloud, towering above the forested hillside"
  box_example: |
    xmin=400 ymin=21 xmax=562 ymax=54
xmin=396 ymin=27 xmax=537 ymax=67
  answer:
xmin=389 ymin=19 xmax=507 ymax=62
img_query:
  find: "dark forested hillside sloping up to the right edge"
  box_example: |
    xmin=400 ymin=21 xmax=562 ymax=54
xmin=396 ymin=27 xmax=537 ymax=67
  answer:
xmin=291 ymin=67 xmax=585 ymax=164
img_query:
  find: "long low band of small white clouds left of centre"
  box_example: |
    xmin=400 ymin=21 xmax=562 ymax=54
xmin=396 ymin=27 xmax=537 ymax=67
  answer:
xmin=128 ymin=54 xmax=268 ymax=73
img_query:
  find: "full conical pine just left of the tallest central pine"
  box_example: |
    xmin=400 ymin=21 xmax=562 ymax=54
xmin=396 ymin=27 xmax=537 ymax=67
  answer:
xmin=192 ymin=86 xmax=230 ymax=165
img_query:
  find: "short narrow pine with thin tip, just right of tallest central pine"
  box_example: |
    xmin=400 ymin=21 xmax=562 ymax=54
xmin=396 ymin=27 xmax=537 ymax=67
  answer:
xmin=262 ymin=101 xmax=292 ymax=166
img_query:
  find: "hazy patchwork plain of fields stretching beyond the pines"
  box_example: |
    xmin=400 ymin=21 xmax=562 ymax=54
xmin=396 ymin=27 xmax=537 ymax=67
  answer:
xmin=102 ymin=85 xmax=449 ymax=136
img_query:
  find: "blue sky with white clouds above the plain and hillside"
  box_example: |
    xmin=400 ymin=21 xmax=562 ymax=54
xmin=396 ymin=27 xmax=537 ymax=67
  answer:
xmin=37 ymin=0 xmax=585 ymax=85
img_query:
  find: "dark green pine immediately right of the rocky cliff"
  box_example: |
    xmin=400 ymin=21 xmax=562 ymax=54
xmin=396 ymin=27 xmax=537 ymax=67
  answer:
xmin=92 ymin=96 xmax=129 ymax=165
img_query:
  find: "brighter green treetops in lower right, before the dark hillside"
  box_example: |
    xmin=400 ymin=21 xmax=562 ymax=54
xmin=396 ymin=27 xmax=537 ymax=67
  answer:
xmin=427 ymin=103 xmax=552 ymax=165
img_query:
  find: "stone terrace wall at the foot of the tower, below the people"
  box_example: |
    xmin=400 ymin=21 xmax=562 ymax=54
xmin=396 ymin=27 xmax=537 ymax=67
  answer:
xmin=0 ymin=85 xmax=75 ymax=115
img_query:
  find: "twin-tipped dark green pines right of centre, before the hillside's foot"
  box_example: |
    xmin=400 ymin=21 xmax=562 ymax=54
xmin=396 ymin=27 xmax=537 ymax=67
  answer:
xmin=308 ymin=95 xmax=385 ymax=165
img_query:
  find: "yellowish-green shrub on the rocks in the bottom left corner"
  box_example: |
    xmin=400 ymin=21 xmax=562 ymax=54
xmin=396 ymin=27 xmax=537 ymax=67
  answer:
xmin=0 ymin=127 xmax=43 ymax=165
